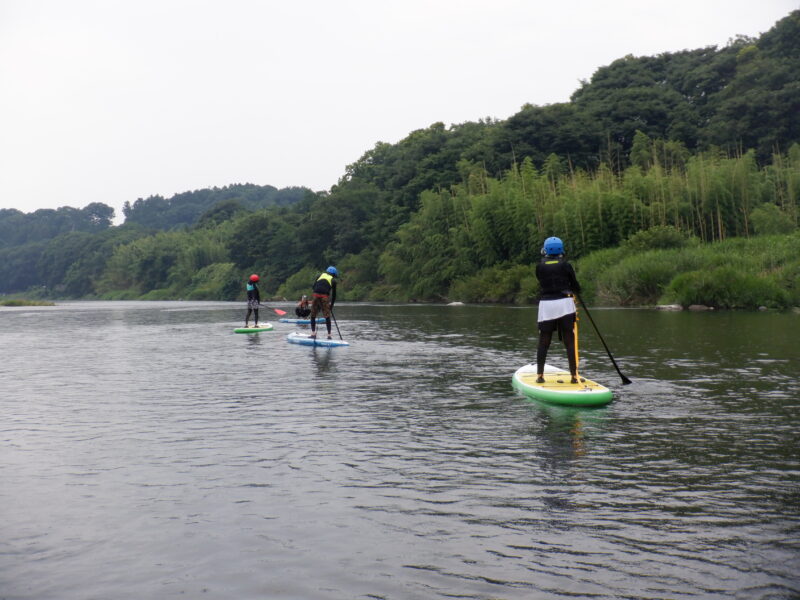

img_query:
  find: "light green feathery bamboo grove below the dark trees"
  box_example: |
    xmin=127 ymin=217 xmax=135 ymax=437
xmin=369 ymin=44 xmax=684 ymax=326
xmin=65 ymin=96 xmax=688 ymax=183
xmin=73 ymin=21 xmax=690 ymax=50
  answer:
xmin=380 ymin=138 xmax=800 ymax=299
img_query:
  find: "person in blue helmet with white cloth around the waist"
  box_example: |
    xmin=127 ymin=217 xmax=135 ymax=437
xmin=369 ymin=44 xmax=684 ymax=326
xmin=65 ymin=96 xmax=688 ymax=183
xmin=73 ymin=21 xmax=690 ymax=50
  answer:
xmin=536 ymin=237 xmax=581 ymax=383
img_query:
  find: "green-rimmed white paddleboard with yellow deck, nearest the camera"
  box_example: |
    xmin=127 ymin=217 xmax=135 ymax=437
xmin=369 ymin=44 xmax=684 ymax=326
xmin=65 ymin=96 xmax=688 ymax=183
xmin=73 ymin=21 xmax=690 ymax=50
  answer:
xmin=511 ymin=365 xmax=612 ymax=406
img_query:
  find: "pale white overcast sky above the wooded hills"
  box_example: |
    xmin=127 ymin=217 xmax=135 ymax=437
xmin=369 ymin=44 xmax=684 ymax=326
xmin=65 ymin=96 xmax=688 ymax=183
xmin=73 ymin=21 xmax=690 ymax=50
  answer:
xmin=0 ymin=0 xmax=800 ymax=222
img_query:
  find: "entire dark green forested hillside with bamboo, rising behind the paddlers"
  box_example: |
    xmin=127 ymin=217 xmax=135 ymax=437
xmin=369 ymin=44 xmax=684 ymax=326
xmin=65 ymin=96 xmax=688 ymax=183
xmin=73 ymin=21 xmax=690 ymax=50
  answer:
xmin=0 ymin=11 xmax=800 ymax=305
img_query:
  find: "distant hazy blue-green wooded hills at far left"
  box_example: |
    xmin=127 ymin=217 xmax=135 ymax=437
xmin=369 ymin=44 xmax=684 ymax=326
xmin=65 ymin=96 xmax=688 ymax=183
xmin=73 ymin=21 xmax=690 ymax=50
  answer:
xmin=0 ymin=184 xmax=315 ymax=298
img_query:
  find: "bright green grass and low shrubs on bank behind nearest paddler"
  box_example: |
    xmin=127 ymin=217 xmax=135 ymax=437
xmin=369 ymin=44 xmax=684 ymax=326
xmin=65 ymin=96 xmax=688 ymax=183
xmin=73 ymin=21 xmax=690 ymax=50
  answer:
xmin=432 ymin=227 xmax=800 ymax=310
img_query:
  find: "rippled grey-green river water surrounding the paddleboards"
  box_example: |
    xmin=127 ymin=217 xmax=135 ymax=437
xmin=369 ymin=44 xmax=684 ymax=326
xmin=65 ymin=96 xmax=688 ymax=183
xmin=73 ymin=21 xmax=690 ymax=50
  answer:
xmin=0 ymin=302 xmax=800 ymax=600
